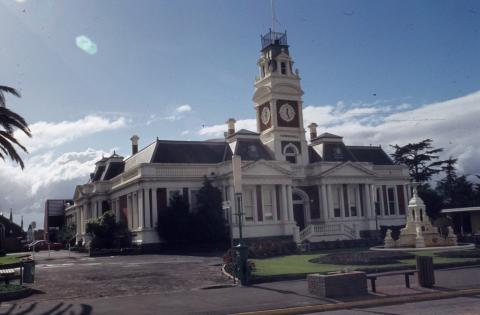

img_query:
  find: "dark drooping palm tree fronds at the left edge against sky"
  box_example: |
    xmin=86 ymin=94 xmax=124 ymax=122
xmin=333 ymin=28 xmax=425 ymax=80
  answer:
xmin=0 ymin=85 xmax=32 ymax=169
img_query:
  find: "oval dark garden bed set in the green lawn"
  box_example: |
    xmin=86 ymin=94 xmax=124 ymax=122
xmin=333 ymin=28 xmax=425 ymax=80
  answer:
xmin=310 ymin=251 xmax=415 ymax=265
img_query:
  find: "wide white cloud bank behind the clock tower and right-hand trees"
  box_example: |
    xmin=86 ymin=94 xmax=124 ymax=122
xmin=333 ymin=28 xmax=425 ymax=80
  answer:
xmin=198 ymin=91 xmax=480 ymax=174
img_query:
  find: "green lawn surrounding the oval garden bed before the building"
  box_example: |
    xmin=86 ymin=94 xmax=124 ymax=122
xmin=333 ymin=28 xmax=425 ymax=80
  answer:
xmin=251 ymin=251 xmax=479 ymax=276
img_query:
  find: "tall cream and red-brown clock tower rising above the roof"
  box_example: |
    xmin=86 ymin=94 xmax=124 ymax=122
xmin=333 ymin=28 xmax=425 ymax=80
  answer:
xmin=253 ymin=30 xmax=308 ymax=164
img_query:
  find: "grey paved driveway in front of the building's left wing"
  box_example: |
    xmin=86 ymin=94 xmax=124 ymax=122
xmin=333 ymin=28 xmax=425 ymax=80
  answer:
xmin=17 ymin=251 xmax=231 ymax=302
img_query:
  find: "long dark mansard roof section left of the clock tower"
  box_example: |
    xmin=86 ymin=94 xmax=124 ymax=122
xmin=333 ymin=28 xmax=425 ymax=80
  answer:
xmin=150 ymin=140 xmax=232 ymax=164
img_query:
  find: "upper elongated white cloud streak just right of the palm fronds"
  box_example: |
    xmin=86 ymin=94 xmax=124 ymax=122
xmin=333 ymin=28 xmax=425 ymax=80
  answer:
xmin=15 ymin=115 xmax=127 ymax=153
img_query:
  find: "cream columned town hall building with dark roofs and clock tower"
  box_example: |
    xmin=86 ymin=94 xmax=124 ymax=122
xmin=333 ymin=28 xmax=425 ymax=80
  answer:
xmin=66 ymin=31 xmax=411 ymax=245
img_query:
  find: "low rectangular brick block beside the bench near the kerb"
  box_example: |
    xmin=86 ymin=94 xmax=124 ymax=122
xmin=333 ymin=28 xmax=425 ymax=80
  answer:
xmin=307 ymin=271 xmax=368 ymax=298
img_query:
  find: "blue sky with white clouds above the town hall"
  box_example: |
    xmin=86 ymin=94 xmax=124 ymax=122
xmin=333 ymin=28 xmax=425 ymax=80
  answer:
xmin=0 ymin=0 xmax=480 ymax=227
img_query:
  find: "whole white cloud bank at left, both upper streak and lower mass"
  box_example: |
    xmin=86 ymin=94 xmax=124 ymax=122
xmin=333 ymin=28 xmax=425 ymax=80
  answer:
xmin=0 ymin=116 xmax=127 ymax=228
